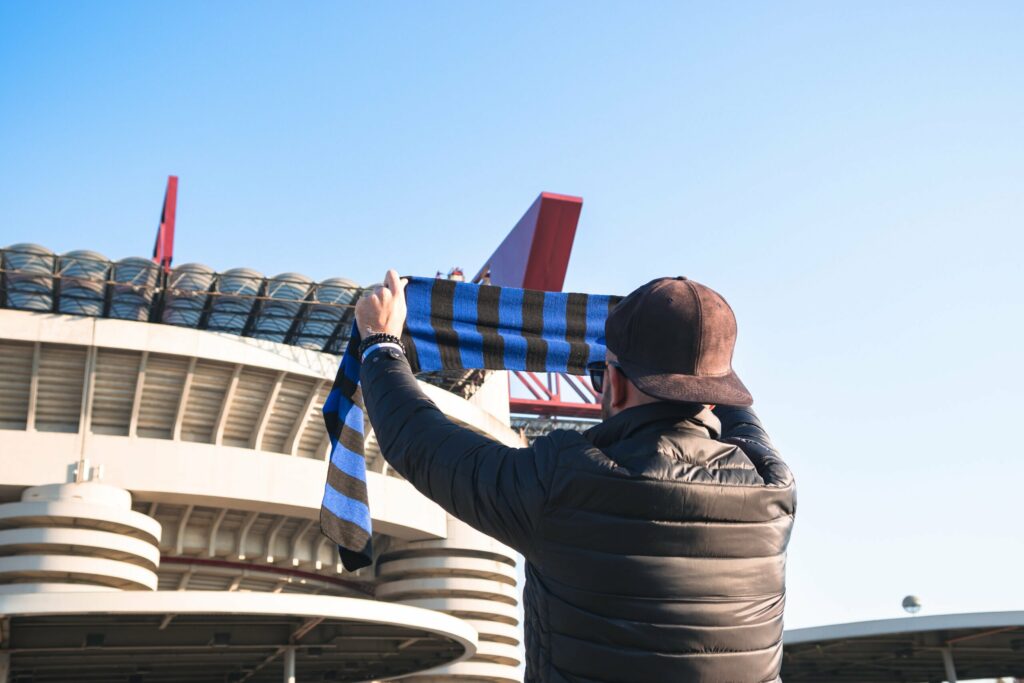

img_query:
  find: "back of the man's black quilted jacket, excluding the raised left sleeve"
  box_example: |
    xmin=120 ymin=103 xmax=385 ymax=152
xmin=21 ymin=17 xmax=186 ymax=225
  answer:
xmin=525 ymin=403 xmax=795 ymax=682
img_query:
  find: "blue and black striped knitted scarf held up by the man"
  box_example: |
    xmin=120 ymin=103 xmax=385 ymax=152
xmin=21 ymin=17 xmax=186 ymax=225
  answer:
xmin=321 ymin=278 xmax=620 ymax=571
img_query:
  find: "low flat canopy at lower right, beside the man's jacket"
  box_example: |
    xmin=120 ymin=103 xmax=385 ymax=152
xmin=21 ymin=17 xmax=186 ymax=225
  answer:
xmin=782 ymin=611 xmax=1024 ymax=683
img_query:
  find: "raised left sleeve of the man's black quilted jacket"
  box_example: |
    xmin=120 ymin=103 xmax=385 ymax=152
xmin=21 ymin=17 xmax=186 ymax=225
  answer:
xmin=360 ymin=349 xmax=555 ymax=553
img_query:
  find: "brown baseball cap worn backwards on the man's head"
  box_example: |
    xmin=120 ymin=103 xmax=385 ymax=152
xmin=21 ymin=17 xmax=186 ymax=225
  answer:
xmin=604 ymin=276 xmax=754 ymax=405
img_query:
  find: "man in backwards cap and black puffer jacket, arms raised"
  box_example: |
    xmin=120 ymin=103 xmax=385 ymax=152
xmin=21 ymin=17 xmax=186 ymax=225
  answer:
xmin=355 ymin=270 xmax=796 ymax=683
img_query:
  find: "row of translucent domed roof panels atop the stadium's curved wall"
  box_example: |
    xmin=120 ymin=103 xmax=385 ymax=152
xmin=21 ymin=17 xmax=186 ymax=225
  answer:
xmin=0 ymin=244 xmax=361 ymax=353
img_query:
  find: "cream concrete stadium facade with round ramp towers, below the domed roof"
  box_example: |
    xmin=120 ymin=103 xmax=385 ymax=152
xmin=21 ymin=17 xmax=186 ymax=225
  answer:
xmin=0 ymin=245 xmax=521 ymax=683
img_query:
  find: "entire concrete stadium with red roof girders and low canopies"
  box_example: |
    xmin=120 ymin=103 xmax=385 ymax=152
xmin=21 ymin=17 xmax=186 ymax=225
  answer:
xmin=0 ymin=177 xmax=1024 ymax=683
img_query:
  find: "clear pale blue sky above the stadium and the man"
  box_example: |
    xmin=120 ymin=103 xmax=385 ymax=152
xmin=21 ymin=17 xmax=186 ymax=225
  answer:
xmin=0 ymin=0 xmax=1024 ymax=627
